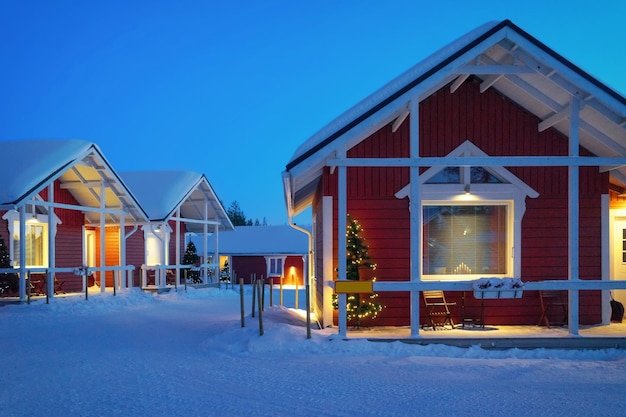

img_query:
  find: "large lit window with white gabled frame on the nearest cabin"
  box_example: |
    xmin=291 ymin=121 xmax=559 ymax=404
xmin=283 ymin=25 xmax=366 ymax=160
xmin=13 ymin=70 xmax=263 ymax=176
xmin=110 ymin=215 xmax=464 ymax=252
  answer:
xmin=395 ymin=141 xmax=539 ymax=281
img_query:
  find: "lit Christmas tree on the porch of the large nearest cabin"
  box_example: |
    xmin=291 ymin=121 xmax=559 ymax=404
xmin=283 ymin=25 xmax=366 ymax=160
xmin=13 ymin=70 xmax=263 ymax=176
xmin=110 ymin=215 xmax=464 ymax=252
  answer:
xmin=333 ymin=215 xmax=384 ymax=327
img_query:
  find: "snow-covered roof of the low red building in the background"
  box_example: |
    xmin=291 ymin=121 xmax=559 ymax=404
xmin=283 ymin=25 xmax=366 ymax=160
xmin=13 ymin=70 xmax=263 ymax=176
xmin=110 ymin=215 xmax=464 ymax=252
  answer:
xmin=191 ymin=225 xmax=309 ymax=255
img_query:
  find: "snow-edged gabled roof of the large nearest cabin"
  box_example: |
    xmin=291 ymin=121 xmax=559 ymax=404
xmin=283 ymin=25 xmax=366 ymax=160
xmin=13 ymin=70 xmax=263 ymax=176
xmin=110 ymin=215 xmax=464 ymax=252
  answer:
xmin=283 ymin=20 xmax=626 ymax=215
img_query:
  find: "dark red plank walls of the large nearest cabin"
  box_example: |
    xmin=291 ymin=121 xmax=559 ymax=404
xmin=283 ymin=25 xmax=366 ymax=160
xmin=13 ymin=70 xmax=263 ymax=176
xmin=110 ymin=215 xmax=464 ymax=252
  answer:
xmin=312 ymin=77 xmax=609 ymax=325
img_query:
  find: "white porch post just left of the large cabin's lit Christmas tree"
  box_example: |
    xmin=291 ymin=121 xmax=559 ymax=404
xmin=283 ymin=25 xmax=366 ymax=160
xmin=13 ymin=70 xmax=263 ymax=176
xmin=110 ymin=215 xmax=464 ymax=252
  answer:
xmin=337 ymin=150 xmax=348 ymax=337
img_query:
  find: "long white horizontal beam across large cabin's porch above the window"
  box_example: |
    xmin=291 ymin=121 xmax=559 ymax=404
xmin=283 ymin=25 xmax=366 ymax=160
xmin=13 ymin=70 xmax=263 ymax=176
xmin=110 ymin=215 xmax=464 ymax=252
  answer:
xmin=326 ymin=156 xmax=626 ymax=168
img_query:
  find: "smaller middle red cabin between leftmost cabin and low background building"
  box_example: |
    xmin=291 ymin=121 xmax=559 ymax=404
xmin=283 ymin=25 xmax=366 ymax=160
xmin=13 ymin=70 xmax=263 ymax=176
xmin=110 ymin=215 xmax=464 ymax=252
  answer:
xmin=118 ymin=171 xmax=234 ymax=289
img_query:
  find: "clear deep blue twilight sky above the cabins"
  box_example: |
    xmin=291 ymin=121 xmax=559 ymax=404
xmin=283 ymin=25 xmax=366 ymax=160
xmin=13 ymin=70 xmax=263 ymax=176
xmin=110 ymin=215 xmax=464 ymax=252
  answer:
xmin=0 ymin=0 xmax=626 ymax=224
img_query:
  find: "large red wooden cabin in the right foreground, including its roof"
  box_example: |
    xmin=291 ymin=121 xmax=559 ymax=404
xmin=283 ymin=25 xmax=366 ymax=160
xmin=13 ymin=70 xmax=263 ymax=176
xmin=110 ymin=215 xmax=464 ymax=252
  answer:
xmin=283 ymin=20 xmax=626 ymax=336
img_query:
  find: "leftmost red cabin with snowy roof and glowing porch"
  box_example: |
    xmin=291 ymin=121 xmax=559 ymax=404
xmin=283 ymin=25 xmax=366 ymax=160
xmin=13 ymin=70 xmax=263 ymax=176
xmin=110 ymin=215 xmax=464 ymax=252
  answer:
xmin=0 ymin=140 xmax=147 ymax=300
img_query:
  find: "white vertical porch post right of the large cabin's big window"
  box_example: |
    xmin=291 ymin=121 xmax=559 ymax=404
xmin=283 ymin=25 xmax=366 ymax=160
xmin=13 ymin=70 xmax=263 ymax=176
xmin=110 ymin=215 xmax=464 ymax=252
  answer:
xmin=568 ymin=96 xmax=580 ymax=336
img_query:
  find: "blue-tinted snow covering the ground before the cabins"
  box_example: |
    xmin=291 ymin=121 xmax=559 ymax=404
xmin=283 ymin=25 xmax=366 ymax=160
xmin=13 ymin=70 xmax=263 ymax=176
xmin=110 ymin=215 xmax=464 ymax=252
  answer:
xmin=0 ymin=288 xmax=626 ymax=417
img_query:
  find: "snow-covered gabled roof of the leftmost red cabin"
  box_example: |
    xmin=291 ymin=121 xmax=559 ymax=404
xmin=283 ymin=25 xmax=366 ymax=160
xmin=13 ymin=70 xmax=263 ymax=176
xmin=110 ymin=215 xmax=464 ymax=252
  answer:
xmin=0 ymin=139 xmax=147 ymax=223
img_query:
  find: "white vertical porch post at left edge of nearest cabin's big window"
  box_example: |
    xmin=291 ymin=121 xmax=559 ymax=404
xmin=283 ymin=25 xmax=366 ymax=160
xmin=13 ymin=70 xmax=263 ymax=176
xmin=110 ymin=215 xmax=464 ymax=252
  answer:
xmin=409 ymin=97 xmax=422 ymax=338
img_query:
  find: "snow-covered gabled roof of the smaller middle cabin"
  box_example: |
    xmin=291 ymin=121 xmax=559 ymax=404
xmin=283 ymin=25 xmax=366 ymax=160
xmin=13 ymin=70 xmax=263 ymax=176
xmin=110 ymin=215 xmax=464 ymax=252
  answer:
xmin=120 ymin=171 xmax=233 ymax=231
